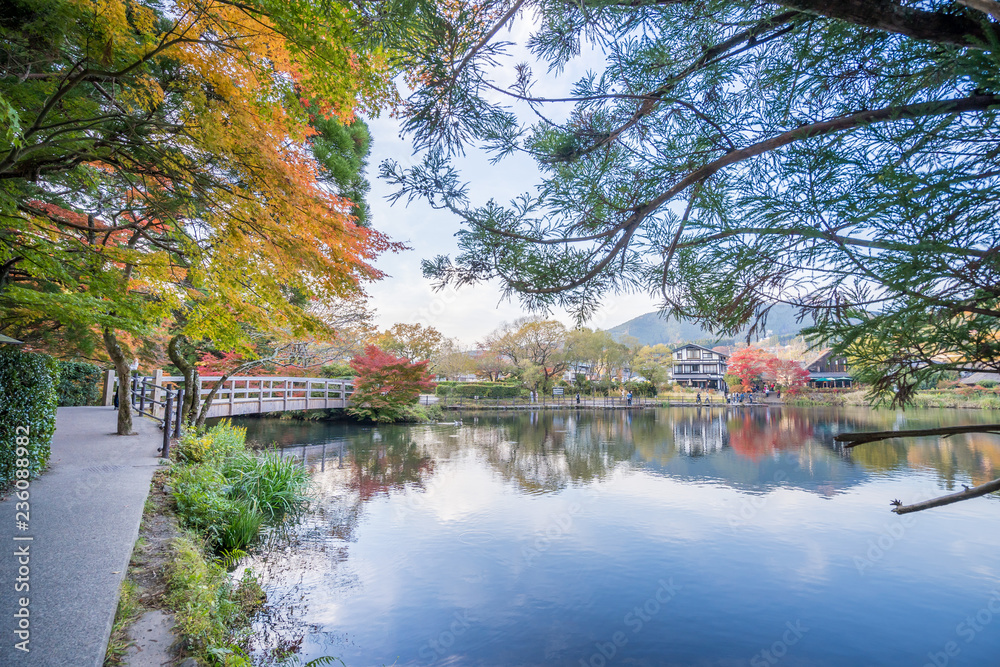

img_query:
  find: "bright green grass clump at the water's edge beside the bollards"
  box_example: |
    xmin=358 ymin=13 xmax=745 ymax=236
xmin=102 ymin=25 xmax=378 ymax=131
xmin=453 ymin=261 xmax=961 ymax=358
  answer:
xmin=171 ymin=421 xmax=309 ymax=556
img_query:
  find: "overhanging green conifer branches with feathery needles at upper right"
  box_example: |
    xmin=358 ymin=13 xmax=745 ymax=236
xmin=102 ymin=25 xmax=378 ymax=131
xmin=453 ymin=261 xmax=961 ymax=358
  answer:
xmin=381 ymin=0 xmax=1000 ymax=402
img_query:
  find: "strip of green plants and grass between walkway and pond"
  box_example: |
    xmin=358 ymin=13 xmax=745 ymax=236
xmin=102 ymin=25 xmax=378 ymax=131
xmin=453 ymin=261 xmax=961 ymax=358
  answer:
xmin=105 ymin=421 xmax=309 ymax=667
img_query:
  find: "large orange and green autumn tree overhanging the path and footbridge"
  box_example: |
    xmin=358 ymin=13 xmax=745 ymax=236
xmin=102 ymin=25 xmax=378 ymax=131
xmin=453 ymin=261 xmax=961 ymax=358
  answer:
xmin=0 ymin=0 xmax=397 ymax=433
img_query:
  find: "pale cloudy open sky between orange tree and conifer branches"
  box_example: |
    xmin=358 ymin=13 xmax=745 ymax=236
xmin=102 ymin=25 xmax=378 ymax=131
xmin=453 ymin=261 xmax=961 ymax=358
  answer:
xmin=356 ymin=19 xmax=657 ymax=345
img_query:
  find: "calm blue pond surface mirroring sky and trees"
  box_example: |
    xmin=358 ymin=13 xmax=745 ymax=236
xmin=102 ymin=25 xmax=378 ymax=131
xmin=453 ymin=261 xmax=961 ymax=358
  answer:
xmin=236 ymin=407 xmax=1000 ymax=667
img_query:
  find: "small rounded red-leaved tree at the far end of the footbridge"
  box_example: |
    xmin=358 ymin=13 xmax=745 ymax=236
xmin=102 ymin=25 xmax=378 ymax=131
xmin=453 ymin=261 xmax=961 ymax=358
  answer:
xmin=347 ymin=345 xmax=434 ymax=422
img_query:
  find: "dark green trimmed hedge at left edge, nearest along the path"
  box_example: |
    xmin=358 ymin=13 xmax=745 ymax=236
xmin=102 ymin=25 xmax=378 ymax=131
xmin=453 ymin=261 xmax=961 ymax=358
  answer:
xmin=0 ymin=345 xmax=59 ymax=487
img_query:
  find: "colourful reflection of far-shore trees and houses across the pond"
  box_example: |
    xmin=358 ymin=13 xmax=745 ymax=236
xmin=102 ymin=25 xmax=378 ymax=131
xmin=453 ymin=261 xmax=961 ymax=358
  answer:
xmin=244 ymin=406 xmax=1000 ymax=499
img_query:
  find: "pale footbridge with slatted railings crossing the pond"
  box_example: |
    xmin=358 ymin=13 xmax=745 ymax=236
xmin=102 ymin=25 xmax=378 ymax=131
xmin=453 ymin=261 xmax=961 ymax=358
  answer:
xmin=104 ymin=371 xmax=354 ymax=419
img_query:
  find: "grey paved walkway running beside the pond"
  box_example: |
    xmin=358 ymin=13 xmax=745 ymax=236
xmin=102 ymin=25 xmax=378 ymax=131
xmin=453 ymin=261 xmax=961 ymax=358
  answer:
xmin=0 ymin=407 xmax=162 ymax=667
